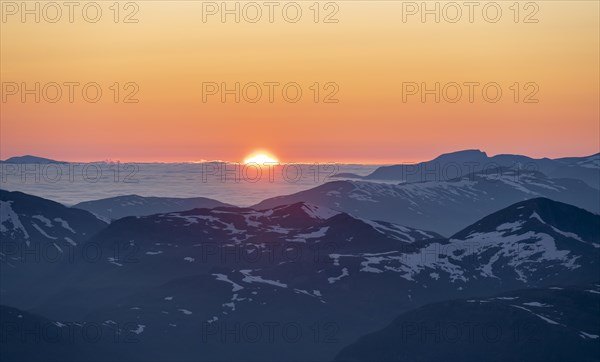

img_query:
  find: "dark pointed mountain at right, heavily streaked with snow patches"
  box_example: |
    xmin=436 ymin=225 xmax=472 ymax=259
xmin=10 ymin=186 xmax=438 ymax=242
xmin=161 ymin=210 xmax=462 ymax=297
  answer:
xmin=310 ymin=198 xmax=600 ymax=287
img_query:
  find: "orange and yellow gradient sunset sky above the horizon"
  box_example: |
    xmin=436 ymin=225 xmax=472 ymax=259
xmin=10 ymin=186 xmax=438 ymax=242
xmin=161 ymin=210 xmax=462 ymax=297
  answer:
xmin=0 ymin=1 xmax=600 ymax=163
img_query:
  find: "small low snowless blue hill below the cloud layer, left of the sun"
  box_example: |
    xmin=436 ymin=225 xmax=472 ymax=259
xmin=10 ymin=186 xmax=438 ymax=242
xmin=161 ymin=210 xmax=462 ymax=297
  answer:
xmin=73 ymin=195 xmax=232 ymax=220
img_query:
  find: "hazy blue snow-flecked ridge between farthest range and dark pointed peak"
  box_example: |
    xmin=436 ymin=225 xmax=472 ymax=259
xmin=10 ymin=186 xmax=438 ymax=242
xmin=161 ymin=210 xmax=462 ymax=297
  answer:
xmin=253 ymin=168 xmax=600 ymax=235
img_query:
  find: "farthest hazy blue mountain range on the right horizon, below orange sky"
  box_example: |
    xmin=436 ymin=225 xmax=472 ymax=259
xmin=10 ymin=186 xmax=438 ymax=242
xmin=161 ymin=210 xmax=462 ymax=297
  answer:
xmin=339 ymin=150 xmax=600 ymax=189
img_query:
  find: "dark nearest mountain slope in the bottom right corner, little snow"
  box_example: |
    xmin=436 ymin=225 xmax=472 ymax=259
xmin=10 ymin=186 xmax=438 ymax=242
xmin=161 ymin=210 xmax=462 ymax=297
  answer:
xmin=336 ymin=284 xmax=600 ymax=361
